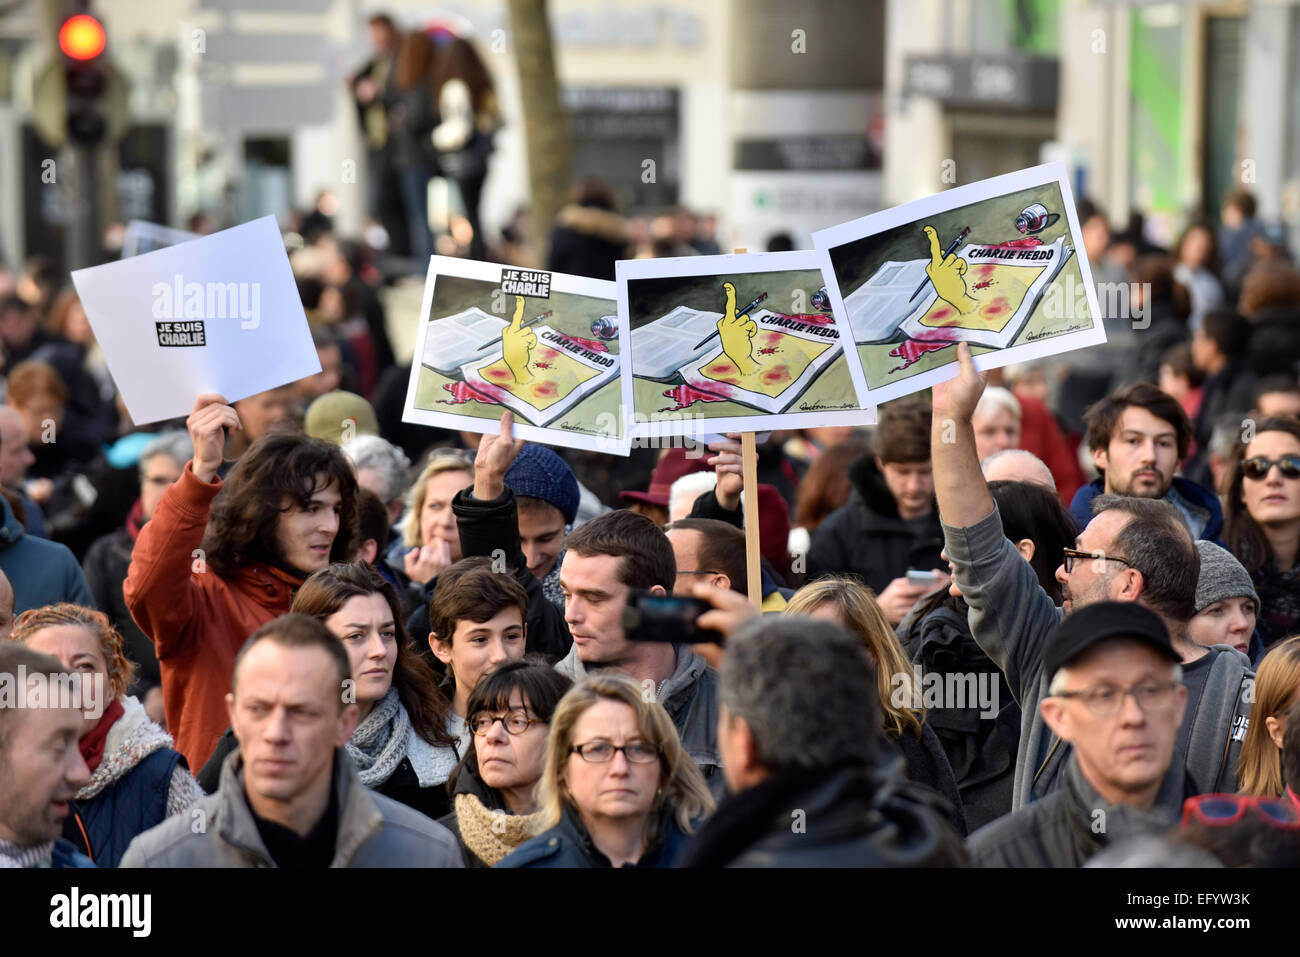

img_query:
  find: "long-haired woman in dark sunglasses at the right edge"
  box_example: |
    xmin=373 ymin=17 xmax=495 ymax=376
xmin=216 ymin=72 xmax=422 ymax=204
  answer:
xmin=1223 ymin=417 xmax=1300 ymax=649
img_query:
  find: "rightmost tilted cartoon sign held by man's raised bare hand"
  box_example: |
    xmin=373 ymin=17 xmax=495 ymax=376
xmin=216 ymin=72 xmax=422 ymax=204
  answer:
xmin=813 ymin=164 xmax=1106 ymax=402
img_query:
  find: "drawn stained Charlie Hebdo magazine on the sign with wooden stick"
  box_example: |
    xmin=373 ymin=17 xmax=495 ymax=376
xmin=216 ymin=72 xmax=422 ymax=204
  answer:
xmin=681 ymin=309 xmax=855 ymax=413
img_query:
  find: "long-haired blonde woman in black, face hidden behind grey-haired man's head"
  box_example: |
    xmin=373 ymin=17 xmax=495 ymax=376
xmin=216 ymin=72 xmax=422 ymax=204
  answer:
xmin=784 ymin=576 xmax=966 ymax=835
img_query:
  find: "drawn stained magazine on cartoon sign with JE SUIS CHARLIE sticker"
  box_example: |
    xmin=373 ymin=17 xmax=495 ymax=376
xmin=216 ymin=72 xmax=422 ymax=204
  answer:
xmin=457 ymin=327 xmax=619 ymax=426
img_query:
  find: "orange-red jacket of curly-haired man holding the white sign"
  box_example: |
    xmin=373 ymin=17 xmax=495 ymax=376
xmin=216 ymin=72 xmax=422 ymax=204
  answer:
xmin=122 ymin=462 xmax=302 ymax=767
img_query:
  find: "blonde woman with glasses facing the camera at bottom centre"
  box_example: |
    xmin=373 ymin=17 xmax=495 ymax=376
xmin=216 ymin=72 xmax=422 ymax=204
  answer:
xmin=497 ymin=674 xmax=714 ymax=867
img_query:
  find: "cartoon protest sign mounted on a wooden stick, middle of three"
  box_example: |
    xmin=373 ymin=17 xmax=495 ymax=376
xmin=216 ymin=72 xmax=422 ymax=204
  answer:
xmin=615 ymin=251 xmax=875 ymax=436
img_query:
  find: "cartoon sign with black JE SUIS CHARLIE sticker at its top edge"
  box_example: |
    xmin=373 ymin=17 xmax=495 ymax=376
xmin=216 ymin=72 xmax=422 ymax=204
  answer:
xmin=402 ymin=256 xmax=631 ymax=455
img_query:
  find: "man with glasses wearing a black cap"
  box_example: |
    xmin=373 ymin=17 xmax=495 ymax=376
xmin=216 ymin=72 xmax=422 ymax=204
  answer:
xmin=966 ymin=602 xmax=1190 ymax=867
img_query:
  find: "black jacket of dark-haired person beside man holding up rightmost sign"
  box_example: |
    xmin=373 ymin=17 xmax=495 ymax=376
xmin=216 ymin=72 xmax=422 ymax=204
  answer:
xmin=898 ymin=597 xmax=1021 ymax=831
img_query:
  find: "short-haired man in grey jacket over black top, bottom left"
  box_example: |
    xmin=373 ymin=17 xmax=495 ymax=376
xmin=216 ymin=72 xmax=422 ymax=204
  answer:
xmin=121 ymin=615 xmax=464 ymax=867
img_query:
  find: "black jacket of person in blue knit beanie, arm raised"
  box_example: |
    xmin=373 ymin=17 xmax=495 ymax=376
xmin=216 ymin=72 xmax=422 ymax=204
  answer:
xmin=407 ymin=489 xmax=573 ymax=660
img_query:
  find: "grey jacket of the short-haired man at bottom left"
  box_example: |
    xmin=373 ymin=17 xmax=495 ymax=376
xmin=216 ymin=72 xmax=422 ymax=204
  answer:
xmin=121 ymin=749 xmax=464 ymax=867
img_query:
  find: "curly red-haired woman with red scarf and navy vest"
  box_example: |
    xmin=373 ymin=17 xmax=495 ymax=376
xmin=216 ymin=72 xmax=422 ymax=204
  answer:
xmin=9 ymin=602 xmax=203 ymax=867
